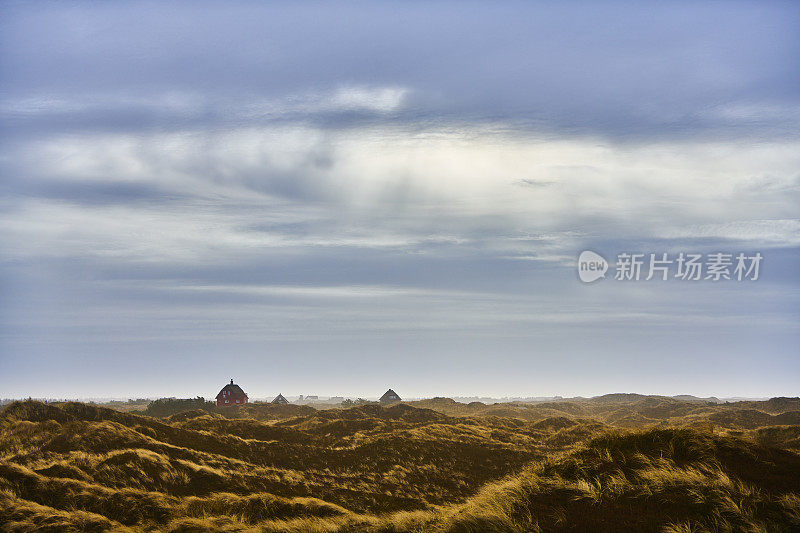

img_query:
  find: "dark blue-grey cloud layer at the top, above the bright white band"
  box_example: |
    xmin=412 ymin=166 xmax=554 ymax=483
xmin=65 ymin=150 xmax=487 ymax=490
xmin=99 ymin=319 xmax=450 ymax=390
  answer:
xmin=0 ymin=2 xmax=800 ymax=140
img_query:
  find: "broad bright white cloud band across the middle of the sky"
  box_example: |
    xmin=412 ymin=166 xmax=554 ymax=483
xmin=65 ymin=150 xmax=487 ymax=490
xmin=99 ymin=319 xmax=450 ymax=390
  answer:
xmin=0 ymin=125 xmax=800 ymax=270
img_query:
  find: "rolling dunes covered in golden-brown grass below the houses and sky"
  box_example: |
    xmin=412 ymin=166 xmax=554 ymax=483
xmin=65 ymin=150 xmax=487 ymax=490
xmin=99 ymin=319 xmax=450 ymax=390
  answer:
xmin=0 ymin=395 xmax=800 ymax=532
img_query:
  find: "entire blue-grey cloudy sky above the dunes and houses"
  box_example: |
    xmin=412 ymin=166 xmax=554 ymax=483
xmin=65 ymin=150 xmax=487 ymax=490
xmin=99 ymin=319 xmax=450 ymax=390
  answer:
xmin=0 ymin=1 xmax=800 ymax=398
